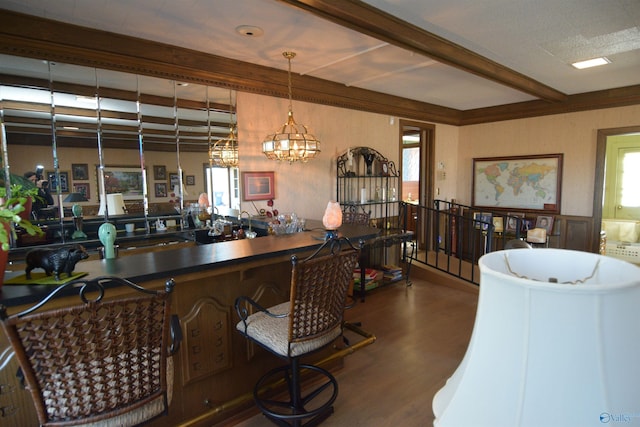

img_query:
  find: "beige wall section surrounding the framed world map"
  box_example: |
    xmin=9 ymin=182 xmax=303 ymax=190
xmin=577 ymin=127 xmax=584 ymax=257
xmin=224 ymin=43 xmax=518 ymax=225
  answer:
xmin=456 ymin=106 xmax=640 ymax=216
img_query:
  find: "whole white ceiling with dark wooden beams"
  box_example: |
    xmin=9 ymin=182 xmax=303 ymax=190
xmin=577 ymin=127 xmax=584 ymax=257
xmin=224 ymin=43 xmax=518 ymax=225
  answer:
xmin=0 ymin=0 xmax=640 ymax=125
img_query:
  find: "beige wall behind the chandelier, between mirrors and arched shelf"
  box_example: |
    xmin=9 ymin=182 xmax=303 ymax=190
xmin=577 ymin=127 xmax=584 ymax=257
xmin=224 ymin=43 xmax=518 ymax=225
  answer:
xmin=238 ymin=88 xmax=399 ymax=219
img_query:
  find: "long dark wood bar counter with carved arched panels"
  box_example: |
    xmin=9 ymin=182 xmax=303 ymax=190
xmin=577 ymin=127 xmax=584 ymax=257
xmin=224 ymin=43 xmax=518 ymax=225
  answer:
xmin=0 ymin=226 xmax=381 ymax=426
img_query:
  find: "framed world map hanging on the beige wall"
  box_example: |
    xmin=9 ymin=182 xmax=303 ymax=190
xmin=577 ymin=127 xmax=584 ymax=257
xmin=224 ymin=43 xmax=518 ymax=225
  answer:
xmin=471 ymin=154 xmax=563 ymax=214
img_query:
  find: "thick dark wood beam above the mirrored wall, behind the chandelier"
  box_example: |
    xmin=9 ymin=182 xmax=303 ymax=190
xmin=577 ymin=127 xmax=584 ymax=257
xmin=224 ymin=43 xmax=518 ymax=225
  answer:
xmin=0 ymin=11 xmax=460 ymax=125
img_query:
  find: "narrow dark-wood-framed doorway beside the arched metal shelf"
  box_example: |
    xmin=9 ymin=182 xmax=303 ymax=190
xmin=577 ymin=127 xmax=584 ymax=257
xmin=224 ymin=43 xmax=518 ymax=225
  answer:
xmin=400 ymin=120 xmax=435 ymax=253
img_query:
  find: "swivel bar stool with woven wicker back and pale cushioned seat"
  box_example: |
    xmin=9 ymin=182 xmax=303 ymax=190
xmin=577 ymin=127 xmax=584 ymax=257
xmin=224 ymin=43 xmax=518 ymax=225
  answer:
xmin=236 ymin=238 xmax=362 ymax=426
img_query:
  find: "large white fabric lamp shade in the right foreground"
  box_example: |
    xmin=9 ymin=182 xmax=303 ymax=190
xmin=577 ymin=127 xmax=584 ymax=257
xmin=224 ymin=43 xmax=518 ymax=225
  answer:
xmin=433 ymin=249 xmax=640 ymax=427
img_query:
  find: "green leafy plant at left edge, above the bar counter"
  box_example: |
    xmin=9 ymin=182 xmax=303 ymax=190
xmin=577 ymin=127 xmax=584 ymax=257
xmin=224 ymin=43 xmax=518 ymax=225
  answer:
xmin=0 ymin=184 xmax=42 ymax=251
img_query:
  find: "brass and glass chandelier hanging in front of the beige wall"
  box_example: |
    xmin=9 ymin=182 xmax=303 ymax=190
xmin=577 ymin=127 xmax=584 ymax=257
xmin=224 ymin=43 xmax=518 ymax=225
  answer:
xmin=262 ymin=52 xmax=320 ymax=163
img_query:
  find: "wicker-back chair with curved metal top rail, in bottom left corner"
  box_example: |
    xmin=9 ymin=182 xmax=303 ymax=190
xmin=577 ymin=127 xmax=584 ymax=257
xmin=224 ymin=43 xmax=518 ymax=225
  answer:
xmin=0 ymin=277 xmax=180 ymax=427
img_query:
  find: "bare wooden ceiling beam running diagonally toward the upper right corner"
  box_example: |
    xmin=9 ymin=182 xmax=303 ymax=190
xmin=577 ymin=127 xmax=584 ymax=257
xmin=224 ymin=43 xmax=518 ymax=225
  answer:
xmin=278 ymin=0 xmax=567 ymax=102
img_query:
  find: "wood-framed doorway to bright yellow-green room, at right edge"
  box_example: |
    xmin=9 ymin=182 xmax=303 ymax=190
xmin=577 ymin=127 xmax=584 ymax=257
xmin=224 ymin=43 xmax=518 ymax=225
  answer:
xmin=592 ymin=126 xmax=640 ymax=253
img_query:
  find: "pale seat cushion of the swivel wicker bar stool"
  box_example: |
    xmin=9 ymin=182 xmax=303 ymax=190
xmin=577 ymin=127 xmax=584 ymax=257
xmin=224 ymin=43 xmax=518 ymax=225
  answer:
xmin=236 ymin=302 xmax=342 ymax=357
